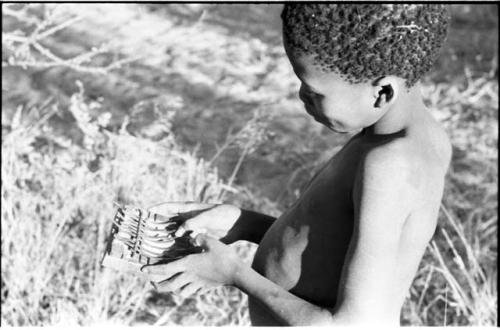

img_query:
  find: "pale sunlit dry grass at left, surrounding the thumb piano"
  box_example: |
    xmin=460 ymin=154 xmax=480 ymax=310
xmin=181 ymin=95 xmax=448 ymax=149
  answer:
xmin=1 ymin=84 xmax=258 ymax=325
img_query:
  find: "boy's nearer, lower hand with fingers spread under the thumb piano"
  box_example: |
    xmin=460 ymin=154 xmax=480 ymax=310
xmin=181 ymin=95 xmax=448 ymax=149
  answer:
xmin=142 ymin=234 xmax=242 ymax=297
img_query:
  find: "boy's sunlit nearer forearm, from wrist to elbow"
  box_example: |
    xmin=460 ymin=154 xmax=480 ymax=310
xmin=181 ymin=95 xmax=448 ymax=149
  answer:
xmin=231 ymin=265 xmax=334 ymax=326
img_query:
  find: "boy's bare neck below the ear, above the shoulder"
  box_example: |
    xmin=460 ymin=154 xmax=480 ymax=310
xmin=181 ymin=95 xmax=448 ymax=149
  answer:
xmin=363 ymin=84 xmax=425 ymax=135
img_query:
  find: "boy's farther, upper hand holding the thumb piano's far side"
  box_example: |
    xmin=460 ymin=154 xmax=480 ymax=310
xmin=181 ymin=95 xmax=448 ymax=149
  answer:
xmin=148 ymin=202 xmax=241 ymax=243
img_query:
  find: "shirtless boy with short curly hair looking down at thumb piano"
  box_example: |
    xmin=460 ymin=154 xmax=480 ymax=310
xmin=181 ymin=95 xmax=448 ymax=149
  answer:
xmin=143 ymin=4 xmax=451 ymax=326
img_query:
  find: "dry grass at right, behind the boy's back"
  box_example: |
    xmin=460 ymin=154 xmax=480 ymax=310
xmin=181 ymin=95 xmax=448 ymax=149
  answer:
xmin=402 ymin=69 xmax=498 ymax=326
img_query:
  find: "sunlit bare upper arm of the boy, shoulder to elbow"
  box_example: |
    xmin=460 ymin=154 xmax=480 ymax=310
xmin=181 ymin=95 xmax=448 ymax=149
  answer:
xmin=339 ymin=150 xmax=415 ymax=319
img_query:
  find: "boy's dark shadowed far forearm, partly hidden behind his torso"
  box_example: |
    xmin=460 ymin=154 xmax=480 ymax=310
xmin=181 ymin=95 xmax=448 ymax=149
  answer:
xmin=223 ymin=209 xmax=276 ymax=244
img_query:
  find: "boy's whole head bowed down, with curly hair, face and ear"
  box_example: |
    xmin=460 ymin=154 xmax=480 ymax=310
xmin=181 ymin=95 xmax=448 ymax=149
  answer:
xmin=281 ymin=4 xmax=449 ymax=132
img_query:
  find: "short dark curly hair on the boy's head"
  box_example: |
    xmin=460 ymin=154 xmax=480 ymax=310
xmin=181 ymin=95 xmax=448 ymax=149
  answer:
xmin=281 ymin=3 xmax=450 ymax=87
